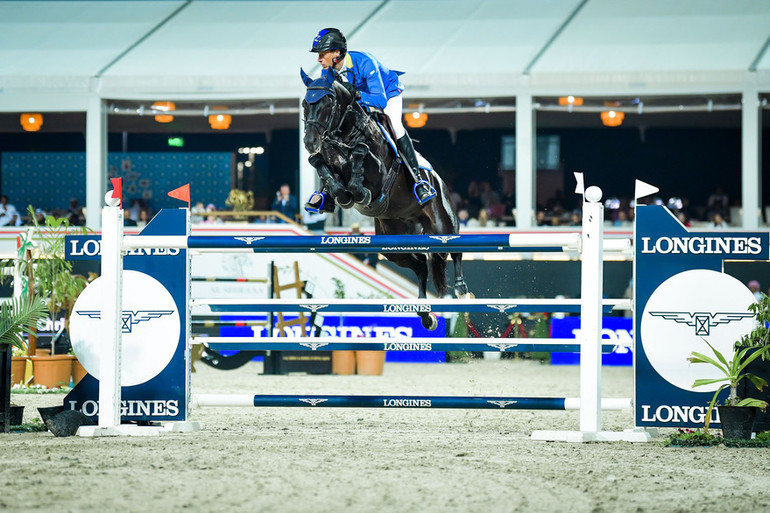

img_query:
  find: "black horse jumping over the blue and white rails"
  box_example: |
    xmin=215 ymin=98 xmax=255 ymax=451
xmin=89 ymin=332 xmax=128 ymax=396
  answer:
xmin=301 ymin=71 xmax=468 ymax=330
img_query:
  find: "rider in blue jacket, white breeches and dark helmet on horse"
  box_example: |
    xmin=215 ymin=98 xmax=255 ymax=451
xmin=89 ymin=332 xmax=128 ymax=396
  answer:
xmin=305 ymin=28 xmax=436 ymax=211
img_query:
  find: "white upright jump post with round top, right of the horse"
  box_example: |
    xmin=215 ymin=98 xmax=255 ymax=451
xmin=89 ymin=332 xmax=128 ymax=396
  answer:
xmin=580 ymin=186 xmax=604 ymax=433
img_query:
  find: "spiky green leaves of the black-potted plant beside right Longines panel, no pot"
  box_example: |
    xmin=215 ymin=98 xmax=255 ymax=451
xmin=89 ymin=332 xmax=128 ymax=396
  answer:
xmin=688 ymin=339 xmax=770 ymax=433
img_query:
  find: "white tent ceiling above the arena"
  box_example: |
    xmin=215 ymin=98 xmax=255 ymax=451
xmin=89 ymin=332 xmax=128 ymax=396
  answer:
xmin=0 ymin=0 xmax=770 ymax=112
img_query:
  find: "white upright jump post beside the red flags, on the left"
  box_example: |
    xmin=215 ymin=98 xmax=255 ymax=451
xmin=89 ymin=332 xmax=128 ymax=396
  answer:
xmin=98 ymin=202 xmax=123 ymax=428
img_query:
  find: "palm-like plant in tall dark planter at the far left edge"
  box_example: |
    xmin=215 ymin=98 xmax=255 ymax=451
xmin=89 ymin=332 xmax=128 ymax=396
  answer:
xmin=0 ymin=296 xmax=47 ymax=432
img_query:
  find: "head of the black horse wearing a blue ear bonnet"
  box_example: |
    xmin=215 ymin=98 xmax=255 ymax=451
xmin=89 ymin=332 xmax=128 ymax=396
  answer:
xmin=300 ymin=69 xmax=352 ymax=155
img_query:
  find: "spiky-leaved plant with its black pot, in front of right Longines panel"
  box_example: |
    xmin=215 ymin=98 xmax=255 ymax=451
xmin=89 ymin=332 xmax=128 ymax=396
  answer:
xmin=688 ymin=340 xmax=770 ymax=439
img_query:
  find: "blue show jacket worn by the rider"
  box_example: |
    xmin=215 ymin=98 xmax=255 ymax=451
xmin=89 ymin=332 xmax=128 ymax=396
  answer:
xmin=322 ymin=52 xmax=404 ymax=109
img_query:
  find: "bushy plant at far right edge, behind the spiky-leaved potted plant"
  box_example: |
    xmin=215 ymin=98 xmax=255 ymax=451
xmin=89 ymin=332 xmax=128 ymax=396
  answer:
xmin=736 ymin=294 xmax=770 ymax=433
